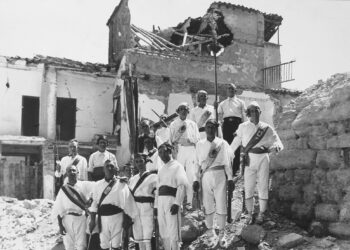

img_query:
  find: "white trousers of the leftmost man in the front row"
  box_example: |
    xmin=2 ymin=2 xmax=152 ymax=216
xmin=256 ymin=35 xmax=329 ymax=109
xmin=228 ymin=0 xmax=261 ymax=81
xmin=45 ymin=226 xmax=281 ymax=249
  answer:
xmin=62 ymin=214 xmax=86 ymax=250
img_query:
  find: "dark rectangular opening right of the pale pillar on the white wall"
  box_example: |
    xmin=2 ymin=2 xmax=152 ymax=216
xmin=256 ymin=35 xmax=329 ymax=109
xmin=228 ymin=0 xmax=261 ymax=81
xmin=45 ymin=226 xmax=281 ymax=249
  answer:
xmin=56 ymin=98 xmax=77 ymax=141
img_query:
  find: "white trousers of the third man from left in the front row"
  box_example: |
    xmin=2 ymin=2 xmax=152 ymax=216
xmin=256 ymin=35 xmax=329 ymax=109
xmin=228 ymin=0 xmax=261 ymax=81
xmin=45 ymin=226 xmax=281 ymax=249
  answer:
xmin=133 ymin=202 xmax=154 ymax=243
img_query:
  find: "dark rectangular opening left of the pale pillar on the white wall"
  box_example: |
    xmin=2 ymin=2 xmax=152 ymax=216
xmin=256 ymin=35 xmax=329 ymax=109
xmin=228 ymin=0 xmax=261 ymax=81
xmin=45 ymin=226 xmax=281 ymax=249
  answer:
xmin=22 ymin=96 xmax=40 ymax=136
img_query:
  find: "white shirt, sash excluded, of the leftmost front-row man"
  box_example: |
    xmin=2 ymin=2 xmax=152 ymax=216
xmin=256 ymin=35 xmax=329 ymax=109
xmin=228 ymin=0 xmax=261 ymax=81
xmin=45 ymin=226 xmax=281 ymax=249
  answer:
xmin=52 ymin=181 xmax=95 ymax=217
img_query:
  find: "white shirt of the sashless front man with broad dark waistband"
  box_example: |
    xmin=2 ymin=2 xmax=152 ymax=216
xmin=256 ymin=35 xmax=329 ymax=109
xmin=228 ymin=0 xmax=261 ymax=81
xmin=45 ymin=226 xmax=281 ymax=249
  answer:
xmin=155 ymin=159 xmax=189 ymax=207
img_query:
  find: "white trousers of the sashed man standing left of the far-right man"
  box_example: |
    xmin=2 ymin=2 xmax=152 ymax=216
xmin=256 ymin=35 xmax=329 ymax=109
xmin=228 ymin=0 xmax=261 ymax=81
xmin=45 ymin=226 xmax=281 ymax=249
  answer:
xmin=202 ymin=170 xmax=227 ymax=215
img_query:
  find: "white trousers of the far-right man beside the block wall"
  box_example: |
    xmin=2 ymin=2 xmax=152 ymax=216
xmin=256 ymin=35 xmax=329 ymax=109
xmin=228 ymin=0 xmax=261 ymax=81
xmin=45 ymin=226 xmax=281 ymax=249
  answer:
xmin=244 ymin=153 xmax=270 ymax=200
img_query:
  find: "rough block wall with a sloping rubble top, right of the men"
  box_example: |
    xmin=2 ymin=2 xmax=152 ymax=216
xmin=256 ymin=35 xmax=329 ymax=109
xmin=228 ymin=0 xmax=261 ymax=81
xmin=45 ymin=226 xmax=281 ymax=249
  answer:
xmin=270 ymin=74 xmax=350 ymax=236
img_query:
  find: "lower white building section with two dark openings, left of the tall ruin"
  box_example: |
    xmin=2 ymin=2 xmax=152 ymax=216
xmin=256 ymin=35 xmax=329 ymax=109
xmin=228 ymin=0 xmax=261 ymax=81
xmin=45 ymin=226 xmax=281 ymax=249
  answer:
xmin=0 ymin=56 xmax=115 ymax=198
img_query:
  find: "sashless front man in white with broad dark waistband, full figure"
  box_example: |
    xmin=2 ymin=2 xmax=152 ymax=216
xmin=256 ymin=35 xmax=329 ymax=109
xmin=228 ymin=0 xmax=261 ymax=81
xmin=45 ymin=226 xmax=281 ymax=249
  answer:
xmin=154 ymin=143 xmax=189 ymax=250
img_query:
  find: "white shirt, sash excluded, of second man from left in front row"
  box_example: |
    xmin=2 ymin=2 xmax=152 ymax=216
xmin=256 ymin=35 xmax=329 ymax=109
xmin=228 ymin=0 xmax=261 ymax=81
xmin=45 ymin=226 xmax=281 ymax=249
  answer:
xmin=90 ymin=179 xmax=137 ymax=218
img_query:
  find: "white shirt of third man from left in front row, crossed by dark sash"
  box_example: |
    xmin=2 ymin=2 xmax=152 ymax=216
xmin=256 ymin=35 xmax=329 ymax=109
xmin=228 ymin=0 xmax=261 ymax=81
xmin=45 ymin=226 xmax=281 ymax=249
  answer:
xmin=129 ymin=171 xmax=158 ymax=197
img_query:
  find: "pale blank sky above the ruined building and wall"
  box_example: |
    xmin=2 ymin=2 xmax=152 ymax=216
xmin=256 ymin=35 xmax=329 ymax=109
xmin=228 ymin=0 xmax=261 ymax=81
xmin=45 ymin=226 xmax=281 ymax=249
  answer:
xmin=0 ymin=0 xmax=350 ymax=89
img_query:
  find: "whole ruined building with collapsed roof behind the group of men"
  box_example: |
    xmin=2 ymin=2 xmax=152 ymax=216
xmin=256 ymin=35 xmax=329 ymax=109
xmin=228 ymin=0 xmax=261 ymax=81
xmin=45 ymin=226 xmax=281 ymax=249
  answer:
xmin=0 ymin=0 xmax=300 ymax=198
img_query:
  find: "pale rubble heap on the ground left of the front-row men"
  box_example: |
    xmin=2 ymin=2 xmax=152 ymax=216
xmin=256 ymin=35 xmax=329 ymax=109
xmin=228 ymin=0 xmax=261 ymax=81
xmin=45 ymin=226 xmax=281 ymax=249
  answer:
xmin=0 ymin=197 xmax=58 ymax=250
